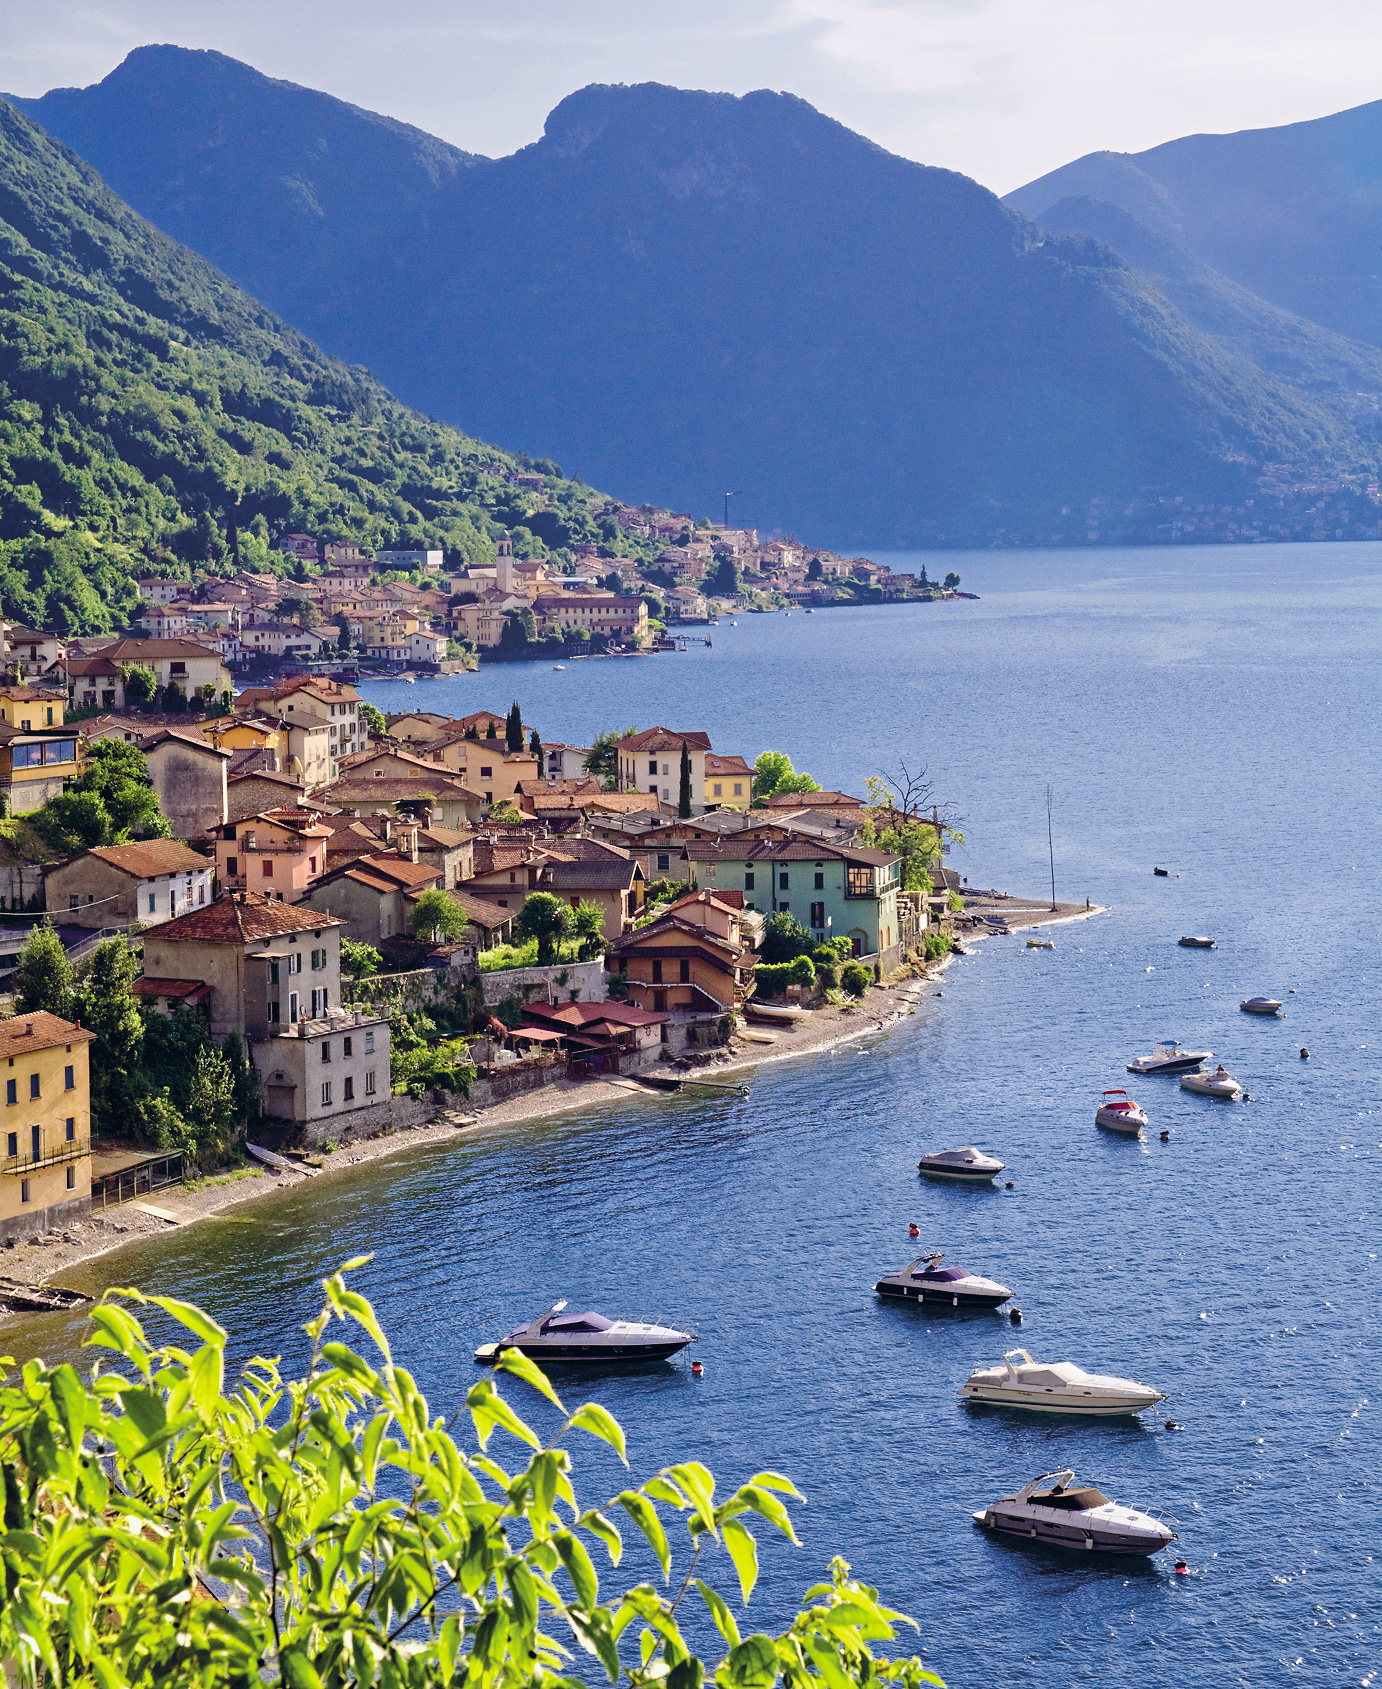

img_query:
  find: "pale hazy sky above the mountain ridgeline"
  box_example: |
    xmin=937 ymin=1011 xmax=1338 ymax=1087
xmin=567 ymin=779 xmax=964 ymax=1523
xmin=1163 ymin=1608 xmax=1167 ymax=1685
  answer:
xmin=0 ymin=0 xmax=1382 ymax=193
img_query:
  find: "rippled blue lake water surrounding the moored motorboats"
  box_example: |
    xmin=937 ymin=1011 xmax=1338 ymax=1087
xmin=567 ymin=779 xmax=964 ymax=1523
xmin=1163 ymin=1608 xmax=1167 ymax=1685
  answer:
xmin=7 ymin=546 xmax=1382 ymax=1689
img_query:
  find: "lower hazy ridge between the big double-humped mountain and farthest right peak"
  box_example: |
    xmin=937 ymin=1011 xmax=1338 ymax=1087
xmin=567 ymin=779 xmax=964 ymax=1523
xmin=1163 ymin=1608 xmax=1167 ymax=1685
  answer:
xmin=1041 ymin=198 xmax=1382 ymax=414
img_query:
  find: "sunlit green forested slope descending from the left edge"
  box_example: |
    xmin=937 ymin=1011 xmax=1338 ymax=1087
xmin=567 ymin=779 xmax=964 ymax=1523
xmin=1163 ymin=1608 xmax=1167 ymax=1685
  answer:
xmin=0 ymin=100 xmax=603 ymax=632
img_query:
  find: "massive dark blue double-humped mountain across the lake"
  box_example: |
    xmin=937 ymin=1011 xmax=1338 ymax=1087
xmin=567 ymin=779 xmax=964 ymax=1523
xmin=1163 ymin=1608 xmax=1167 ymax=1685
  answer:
xmin=13 ymin=47 xmax=1377 ymax=546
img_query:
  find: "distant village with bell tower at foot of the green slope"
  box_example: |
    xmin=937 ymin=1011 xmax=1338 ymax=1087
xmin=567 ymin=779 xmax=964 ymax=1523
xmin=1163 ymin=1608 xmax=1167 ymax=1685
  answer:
xmin=0 ymin=496 xmax=971 ymax=713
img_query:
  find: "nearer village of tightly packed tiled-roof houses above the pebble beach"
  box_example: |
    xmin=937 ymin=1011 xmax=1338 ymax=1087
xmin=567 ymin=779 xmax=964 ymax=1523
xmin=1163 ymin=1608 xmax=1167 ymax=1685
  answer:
xmin=0 ymin=650 xmax=965 ymax=1263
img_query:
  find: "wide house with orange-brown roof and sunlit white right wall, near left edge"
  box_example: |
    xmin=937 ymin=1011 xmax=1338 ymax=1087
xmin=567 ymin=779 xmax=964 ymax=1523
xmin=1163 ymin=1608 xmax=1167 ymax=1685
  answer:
xmin=44 ymin=839 xmax=215 ymax=929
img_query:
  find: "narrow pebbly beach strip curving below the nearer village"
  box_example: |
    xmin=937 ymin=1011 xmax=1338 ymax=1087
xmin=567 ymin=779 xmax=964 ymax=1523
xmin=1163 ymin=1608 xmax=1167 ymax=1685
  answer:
xmin=0 ymin=899 xmax=1108 ymax=1331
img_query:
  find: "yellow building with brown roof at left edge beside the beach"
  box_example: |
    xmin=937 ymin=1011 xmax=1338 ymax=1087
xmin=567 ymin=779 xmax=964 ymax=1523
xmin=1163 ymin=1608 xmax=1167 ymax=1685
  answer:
xmin=0 ymin=1012 xmax=93 ymax=1238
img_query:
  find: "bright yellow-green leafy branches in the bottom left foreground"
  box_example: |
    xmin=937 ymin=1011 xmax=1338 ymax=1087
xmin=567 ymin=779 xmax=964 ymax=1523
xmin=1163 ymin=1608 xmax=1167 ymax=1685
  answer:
xmin=0 ymin=1257 xmax=941 ymax=1689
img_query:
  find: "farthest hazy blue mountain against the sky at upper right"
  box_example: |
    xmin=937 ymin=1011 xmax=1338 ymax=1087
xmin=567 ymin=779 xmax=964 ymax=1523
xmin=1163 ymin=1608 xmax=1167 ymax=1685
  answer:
xmin=1005 ymin=100 xmax=1382 ymax=346
